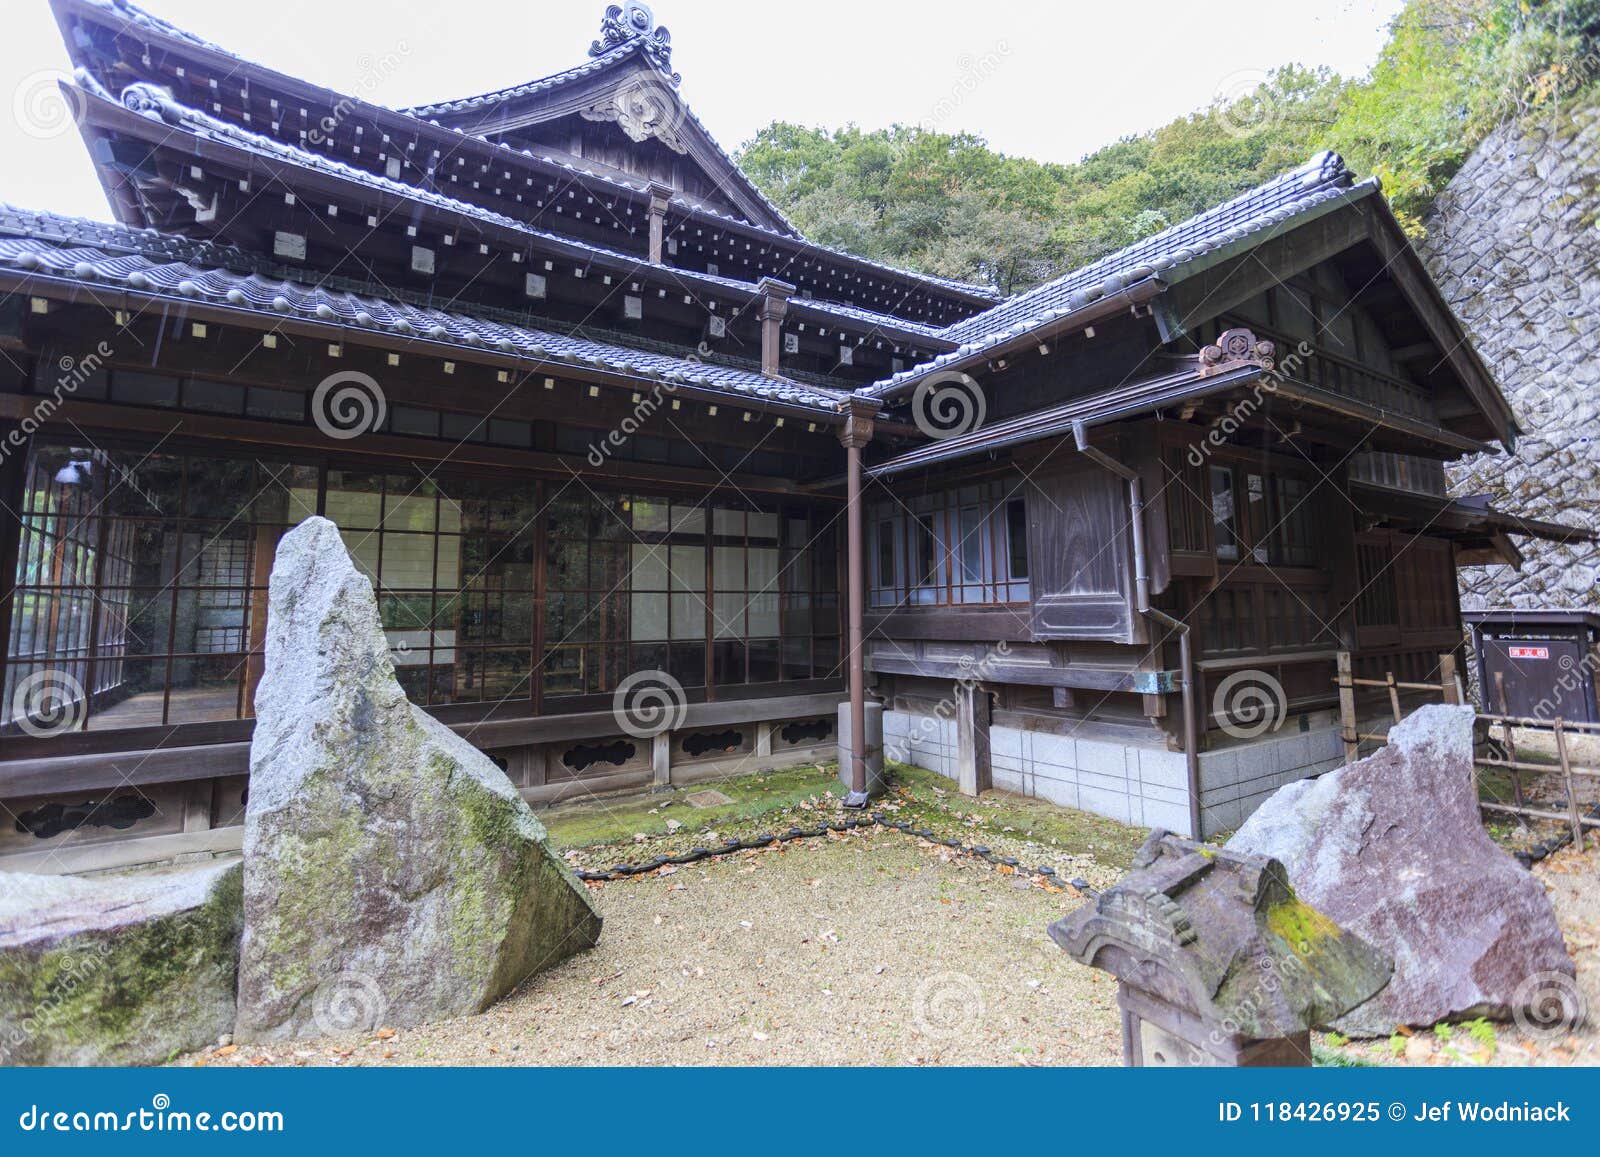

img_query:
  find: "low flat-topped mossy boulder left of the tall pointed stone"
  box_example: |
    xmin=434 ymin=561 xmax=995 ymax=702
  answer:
xmin=0 ymin=861 xmax=240 ymax=1064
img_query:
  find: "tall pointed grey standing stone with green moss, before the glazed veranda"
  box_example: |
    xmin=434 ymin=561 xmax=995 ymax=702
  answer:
xmin=238 ymin=518 xmax=600 ymax=1040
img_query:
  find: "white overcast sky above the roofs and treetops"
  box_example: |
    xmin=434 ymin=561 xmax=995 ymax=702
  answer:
xmin=0 ymin=0 xmax=1400 ymax=218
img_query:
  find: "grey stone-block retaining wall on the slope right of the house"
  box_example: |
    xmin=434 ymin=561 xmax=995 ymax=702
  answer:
xmin=1419 ymin=96 xmax=1600 ymax=610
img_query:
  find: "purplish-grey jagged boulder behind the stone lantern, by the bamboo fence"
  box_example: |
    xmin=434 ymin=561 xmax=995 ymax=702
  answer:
xmin=1227 ymin=704 xmax=1573 ymax=1035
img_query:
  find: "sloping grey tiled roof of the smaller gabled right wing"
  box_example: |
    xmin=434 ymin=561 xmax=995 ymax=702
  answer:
xmin=867 ymin=152 xmax=1378 ymax=395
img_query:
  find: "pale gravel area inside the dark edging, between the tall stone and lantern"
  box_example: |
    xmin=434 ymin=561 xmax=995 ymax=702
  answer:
xmin=189 ymin=832 xmax=1120 ymax=1066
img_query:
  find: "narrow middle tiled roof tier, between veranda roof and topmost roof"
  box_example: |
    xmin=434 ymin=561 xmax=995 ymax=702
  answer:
xmin=90 ymin=82 xmax=944 ymax=349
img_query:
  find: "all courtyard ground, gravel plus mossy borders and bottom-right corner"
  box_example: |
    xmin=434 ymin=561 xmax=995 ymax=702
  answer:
xmin=179 ymin=773 xmax=1600 ymax=1066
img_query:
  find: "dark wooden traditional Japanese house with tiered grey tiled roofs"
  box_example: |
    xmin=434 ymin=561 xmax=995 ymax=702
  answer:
xmin=0 ymin=0 xmax=1573 ymax=871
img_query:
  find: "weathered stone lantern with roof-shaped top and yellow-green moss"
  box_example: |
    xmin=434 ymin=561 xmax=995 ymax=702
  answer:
xmin=1050 ymin=829 xmax=1394 ymax=1066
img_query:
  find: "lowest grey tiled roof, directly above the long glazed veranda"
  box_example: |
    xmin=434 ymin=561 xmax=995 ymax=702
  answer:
xmin=0 ymin=206 xmax=843 ymax=411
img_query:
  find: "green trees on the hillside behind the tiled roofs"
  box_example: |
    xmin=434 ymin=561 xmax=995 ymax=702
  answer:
xmin=741 ymin=0 xmax=1600 ymax=293
